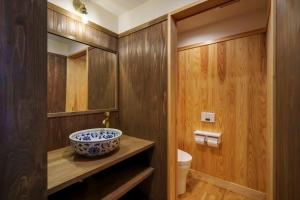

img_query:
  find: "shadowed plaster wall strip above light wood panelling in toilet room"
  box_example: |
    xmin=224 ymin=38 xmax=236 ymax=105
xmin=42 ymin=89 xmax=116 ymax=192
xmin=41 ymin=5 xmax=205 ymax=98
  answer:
xmin=178 ymin=10 xmax=266 ymax=47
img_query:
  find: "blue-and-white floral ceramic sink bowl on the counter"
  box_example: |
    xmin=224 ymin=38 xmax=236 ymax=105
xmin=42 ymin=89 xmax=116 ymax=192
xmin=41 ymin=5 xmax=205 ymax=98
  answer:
xmin=69 ymin=128 xmax=122 ymax=157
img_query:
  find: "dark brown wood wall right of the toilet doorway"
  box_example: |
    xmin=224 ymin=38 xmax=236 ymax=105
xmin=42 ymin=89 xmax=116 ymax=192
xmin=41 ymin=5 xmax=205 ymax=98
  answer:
xmin=274 ymin=0 xmax=300 ymax=200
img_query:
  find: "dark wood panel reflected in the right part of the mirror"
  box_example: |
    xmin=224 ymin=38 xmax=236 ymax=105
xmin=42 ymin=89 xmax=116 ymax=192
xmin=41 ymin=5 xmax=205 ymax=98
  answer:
xmin=88 ymin=48 xmax=118 ymax=110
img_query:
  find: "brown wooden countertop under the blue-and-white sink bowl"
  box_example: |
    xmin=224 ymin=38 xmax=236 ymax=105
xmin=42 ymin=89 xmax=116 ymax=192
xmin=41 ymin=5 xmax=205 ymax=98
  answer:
xmin=47 ymin=135 xmax=154 ymax=195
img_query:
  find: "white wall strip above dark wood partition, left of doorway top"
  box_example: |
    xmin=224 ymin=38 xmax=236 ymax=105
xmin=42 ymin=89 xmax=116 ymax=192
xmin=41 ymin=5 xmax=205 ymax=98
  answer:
xmin=119 ymin=0 xmax=200 ymax=33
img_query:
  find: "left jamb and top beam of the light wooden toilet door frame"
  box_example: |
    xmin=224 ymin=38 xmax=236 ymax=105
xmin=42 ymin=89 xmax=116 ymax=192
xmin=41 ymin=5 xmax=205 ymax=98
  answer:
xmin=167 ymin=0 xmax=274 ymax=200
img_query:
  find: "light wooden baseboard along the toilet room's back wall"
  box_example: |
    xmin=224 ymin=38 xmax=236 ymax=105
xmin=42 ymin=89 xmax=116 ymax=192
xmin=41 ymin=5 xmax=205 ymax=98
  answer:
xmin=190 ymin=170 xmax=266 ymax=200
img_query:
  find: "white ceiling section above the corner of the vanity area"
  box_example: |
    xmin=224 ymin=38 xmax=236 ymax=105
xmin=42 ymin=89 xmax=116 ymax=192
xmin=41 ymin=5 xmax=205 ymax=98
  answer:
xmin=90 ymin=0 xmax=148 ymax=16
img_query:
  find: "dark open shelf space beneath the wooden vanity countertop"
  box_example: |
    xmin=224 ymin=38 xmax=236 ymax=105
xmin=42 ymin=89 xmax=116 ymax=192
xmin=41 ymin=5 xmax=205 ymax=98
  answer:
xmin=48 ymin=164 xmax=154 ymax=200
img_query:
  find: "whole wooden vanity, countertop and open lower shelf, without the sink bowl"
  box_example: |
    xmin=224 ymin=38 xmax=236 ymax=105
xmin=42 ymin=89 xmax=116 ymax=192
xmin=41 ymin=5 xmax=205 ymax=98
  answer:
xmin=47 ymin=135 xmax=154 ymax=200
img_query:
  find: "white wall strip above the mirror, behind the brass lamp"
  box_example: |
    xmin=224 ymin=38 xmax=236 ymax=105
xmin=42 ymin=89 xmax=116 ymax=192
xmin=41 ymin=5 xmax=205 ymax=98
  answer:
xmin=48 ymin=0 xmax=118 ymax=33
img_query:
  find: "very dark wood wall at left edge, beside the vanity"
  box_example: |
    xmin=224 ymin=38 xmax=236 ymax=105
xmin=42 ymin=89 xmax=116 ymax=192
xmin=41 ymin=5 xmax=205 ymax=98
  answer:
xmin=0 ymin=0 xmax=47 ymax=200
